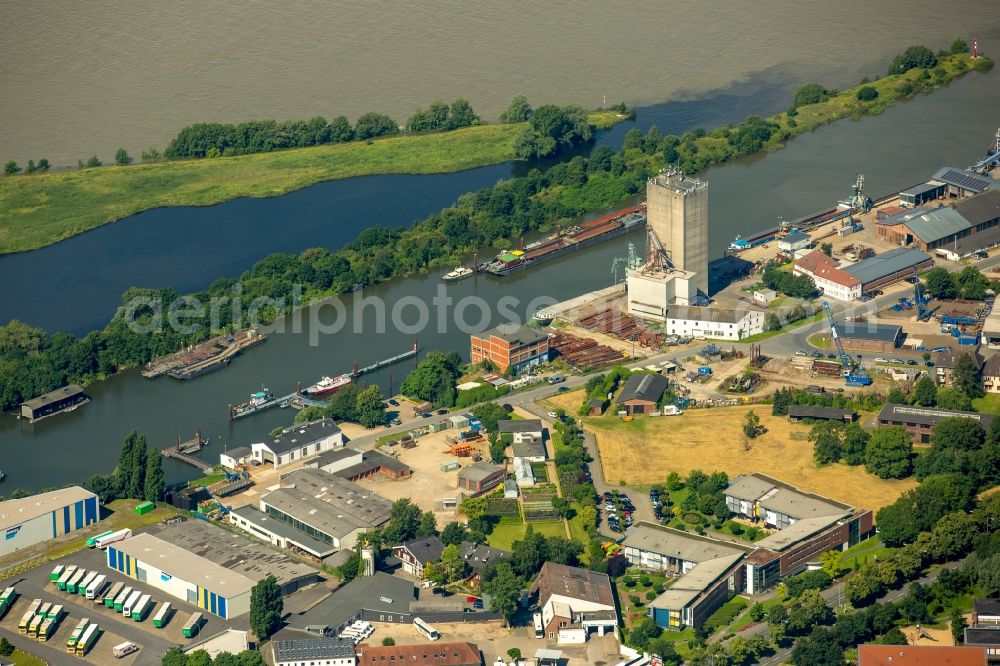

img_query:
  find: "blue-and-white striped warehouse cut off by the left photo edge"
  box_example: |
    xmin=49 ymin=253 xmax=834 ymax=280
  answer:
xmin=0 ymin=486 xmax=101 ymax=556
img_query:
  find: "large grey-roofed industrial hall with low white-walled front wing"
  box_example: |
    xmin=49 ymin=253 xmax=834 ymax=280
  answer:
xmin=244 ymin=468 xmax=392 ymax=557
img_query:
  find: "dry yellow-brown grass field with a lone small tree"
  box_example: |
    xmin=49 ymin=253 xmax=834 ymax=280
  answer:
xmin=588 ymin=404 xmax=916 ymax=509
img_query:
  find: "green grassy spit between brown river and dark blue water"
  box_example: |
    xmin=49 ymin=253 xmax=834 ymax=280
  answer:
xmin=0 ymin=112 xmax=620 ymax=253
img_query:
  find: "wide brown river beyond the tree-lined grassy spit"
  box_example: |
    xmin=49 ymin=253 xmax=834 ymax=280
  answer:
xmin=0 ymin=0 xmax=1000 ymax=165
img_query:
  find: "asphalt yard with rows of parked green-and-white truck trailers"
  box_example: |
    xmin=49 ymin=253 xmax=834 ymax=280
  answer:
xmin=0 ymin=549 xmax=229 ymax=666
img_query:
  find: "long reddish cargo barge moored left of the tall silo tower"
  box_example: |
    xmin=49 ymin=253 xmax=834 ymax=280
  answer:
xmin=477 ymin=204 xmax=646 ymax=277
